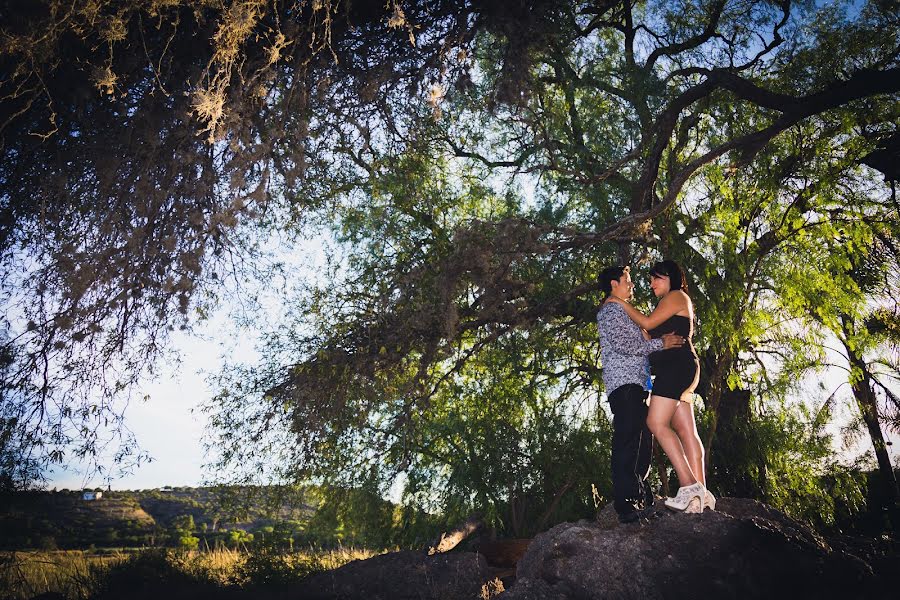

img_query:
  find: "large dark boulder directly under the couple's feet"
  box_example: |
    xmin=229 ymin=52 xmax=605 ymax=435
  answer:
xmin=501 ymin=498 xmax=878 ymax=600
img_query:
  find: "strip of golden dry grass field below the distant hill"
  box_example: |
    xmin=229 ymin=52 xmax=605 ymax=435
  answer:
xmin=0 ymin=548 xmax=375 ymax=600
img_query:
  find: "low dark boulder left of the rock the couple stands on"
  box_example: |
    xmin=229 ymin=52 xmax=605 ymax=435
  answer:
xmin=290 ymin=551 xmax=503 ymax=600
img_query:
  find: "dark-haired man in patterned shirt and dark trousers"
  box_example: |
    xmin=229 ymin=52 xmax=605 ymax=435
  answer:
xmin=597 ymin=266 xmax=684 ymax=523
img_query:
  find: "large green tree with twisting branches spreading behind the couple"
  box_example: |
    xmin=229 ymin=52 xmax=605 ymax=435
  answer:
xmin=206 ymin=0 xmax=896 ymax=528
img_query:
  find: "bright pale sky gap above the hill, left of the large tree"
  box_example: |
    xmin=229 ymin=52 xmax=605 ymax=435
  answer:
xmin=47 ymin=232 xmax=328 ymax=490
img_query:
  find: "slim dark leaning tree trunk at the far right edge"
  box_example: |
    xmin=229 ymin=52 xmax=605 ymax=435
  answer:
xmin=841 ymin=340 xmax=900 ymax=532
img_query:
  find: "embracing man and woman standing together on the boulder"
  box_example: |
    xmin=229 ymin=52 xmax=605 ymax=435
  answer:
xmin=597 ymin=260 xmax=716 ymax=523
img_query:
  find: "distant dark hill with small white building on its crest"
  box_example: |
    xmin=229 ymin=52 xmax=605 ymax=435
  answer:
xmin=0 ymin=487 xmax=316 ymax=550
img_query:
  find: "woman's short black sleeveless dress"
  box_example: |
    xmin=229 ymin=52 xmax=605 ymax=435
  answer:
xmin=649 ymin=315 xmax=700 ymax=402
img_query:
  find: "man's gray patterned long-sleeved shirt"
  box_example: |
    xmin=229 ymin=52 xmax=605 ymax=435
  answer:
xmin=597 ymin=302 xmax=663 ymax=398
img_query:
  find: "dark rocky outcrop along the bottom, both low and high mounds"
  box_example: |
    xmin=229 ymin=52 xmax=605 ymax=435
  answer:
xmin=280 ymin=498 xmax=900 ymax=600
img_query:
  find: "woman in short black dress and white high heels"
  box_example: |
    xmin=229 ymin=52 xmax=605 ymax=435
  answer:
xmin=612 ymin=260 xmax=716 ymax=512
